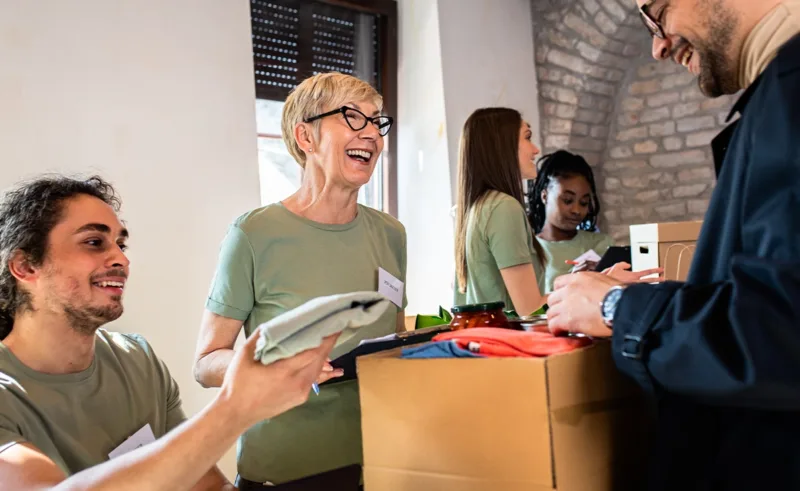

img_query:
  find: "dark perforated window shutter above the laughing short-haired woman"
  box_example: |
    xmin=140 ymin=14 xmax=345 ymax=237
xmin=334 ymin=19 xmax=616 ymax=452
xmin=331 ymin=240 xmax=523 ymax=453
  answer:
xmin=250 ymin=0 xmax=381 ymax=100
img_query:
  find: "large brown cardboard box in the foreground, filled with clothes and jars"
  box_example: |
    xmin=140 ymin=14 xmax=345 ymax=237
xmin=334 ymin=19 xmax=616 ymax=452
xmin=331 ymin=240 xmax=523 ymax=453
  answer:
xmin=358 ymin=342 xmax=651 ymax=491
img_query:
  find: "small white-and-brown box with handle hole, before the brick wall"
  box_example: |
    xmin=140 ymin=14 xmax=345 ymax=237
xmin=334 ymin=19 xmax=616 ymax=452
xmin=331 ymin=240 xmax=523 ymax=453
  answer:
xmin=630 ymin=221 xmax=703 ymax=281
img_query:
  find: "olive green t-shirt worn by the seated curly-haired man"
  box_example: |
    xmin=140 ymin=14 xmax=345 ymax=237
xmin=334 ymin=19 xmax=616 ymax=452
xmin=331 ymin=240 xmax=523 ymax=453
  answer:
xmin=0 ymin=329 xmax=186 ymax=476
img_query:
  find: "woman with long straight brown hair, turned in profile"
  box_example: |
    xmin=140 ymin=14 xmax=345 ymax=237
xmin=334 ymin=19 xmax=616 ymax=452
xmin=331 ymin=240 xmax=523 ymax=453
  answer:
xmin=455 ymin=107 xmax=546 ymax=315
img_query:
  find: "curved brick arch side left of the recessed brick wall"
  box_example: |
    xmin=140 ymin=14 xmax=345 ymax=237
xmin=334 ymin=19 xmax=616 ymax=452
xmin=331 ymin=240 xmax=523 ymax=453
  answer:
xmin=533 ymin=0 xmax=642 ymax=166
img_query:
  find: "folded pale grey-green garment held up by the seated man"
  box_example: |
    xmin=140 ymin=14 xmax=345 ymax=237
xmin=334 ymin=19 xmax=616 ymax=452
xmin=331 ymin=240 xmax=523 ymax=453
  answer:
xmin=255 ymin=292 xmax=391 ymax=365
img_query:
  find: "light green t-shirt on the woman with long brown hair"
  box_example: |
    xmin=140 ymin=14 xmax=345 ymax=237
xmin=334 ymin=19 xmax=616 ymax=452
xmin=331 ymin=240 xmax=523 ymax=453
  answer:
xmin=454 ymin=191 xmax=544 ymax=309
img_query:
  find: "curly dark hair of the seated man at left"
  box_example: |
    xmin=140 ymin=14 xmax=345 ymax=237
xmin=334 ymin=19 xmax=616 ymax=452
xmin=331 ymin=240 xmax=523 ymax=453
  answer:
xmin=0 ymin=175 xmax=122 ymax=340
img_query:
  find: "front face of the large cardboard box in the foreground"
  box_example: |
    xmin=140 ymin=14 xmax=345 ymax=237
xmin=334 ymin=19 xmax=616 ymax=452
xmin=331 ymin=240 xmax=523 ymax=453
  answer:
xmin=358 ymin=350 xmax=553 ymax=489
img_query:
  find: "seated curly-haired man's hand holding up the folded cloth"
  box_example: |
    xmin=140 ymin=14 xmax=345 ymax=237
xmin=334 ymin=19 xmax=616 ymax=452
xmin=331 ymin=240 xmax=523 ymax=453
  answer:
xmin=220 ymin=330 xmax=339 ymax=427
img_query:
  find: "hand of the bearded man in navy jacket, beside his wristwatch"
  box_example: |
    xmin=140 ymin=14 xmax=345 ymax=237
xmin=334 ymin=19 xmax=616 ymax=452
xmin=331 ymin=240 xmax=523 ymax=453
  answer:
xmin=547 ymin=273 xmax=622 ymax=337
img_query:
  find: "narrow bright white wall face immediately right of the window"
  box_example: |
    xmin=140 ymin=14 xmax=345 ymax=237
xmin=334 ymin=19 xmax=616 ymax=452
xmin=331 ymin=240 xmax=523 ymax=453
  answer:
xmin=397 ymin=0 xmax=453 ymax=314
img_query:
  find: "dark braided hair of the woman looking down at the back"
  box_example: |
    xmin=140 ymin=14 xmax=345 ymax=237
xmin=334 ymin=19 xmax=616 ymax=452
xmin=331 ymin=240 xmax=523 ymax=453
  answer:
xmin=528 ymin=150 xmax=600 ymax=234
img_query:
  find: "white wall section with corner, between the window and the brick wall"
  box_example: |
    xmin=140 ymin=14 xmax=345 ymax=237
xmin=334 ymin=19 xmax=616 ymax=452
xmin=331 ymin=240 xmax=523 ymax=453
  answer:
xmin=398 ymin=0 xmax=539 ymax=314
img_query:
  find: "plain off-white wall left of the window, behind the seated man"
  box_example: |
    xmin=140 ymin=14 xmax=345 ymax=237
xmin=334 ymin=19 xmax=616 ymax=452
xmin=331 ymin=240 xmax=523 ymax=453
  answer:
xmin=0 ymin=0 xmax=259 ymax=475
